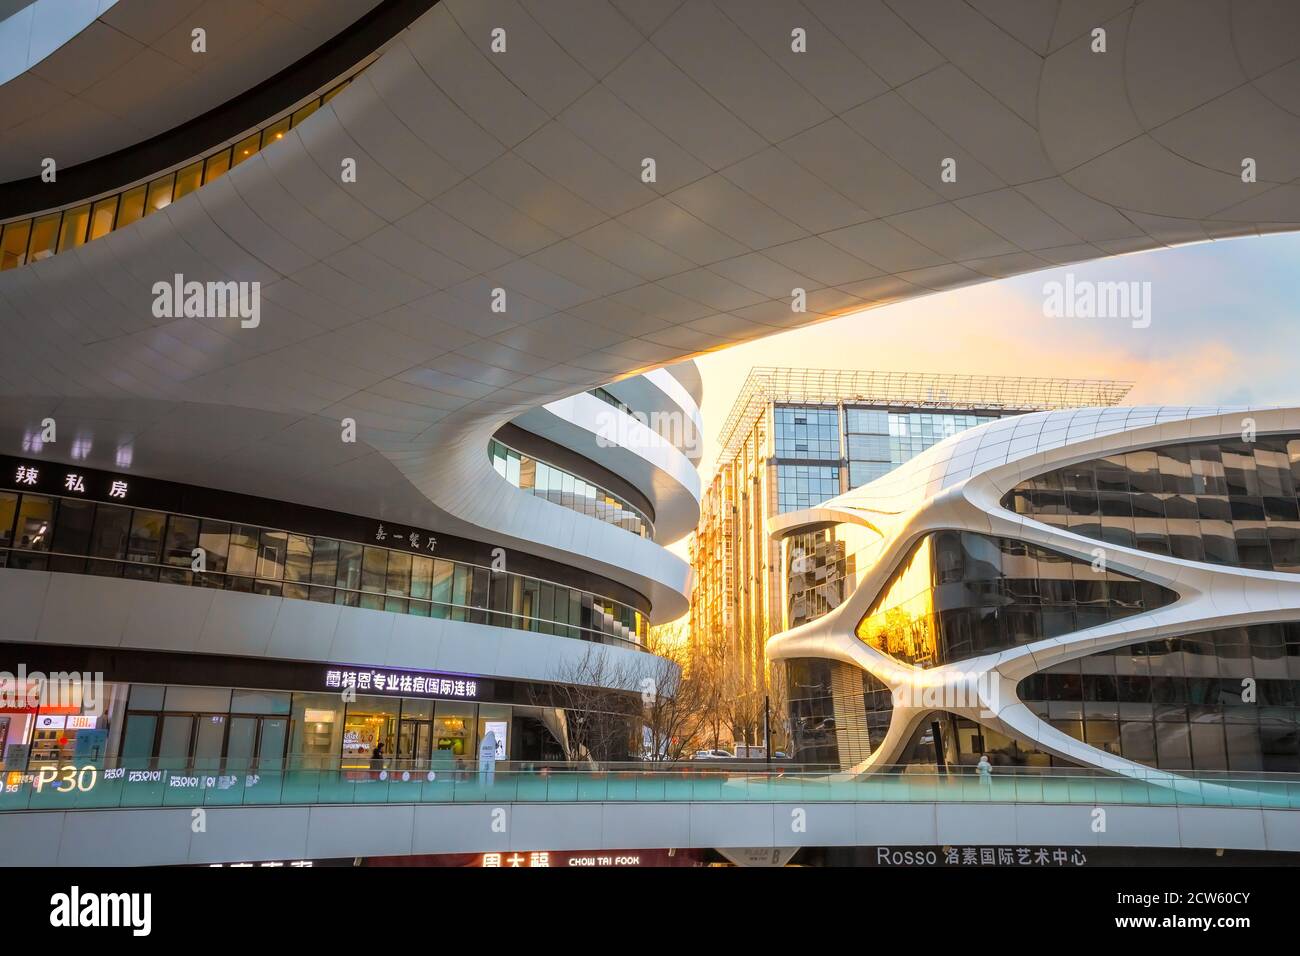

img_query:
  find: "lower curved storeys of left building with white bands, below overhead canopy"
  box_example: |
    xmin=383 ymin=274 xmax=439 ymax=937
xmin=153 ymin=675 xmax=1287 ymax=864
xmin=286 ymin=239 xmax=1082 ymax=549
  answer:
xmin=0 ymin=364 xmax=699 ymax=773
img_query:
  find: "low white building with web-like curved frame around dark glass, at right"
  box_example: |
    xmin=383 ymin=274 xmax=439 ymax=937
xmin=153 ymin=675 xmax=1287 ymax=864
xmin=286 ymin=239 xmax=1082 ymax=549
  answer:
xmin=767 ymin=407 xmax=1300 ymax=777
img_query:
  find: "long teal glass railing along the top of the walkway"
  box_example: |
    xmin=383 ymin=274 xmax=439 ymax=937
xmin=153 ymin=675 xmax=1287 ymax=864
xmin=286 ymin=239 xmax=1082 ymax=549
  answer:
xmin=0 ymin=762 xmax=1300 ymax=812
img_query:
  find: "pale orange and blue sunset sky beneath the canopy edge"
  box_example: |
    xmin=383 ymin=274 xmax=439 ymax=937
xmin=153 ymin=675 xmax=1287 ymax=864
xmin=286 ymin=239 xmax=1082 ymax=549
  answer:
xmin=671 ymin=233 xmax=1300 ymax=574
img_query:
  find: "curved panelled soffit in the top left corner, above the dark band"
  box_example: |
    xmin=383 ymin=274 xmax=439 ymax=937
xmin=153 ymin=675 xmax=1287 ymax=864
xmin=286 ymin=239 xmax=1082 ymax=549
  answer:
xmin=0 ymin=0 xmax=380 ymax=184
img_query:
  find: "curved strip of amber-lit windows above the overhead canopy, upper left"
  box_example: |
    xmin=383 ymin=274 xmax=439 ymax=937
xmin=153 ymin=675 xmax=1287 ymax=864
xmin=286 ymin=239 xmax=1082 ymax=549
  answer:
xmin=0 ymin=70 xmax=360 ymax=271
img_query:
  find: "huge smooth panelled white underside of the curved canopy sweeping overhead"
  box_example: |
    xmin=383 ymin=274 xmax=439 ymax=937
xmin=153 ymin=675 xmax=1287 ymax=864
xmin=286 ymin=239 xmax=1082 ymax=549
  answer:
xmin=0 ymin=0 xmax=1300 ymax=621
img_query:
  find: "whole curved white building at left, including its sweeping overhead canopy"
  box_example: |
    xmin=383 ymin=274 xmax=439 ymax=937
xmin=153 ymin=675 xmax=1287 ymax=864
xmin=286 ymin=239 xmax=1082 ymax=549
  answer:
xmin=0 ymin=0 xmax=1300 ymax=790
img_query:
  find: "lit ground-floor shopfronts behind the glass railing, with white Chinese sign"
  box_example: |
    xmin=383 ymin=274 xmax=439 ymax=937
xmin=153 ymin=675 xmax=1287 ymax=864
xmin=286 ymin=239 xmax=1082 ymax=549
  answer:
xmin=0 ymin=645 xmax=579 ymax=774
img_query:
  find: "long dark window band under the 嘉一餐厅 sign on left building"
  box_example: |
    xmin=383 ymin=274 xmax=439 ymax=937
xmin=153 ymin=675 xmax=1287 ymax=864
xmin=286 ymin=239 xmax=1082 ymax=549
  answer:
xmin=0 ymin=492 xmax=649 ymax=646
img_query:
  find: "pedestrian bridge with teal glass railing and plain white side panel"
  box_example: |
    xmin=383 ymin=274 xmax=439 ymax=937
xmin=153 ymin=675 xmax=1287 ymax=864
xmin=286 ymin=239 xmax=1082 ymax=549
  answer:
xmin=0 ymin=769 xmax=1300 ymax=865
